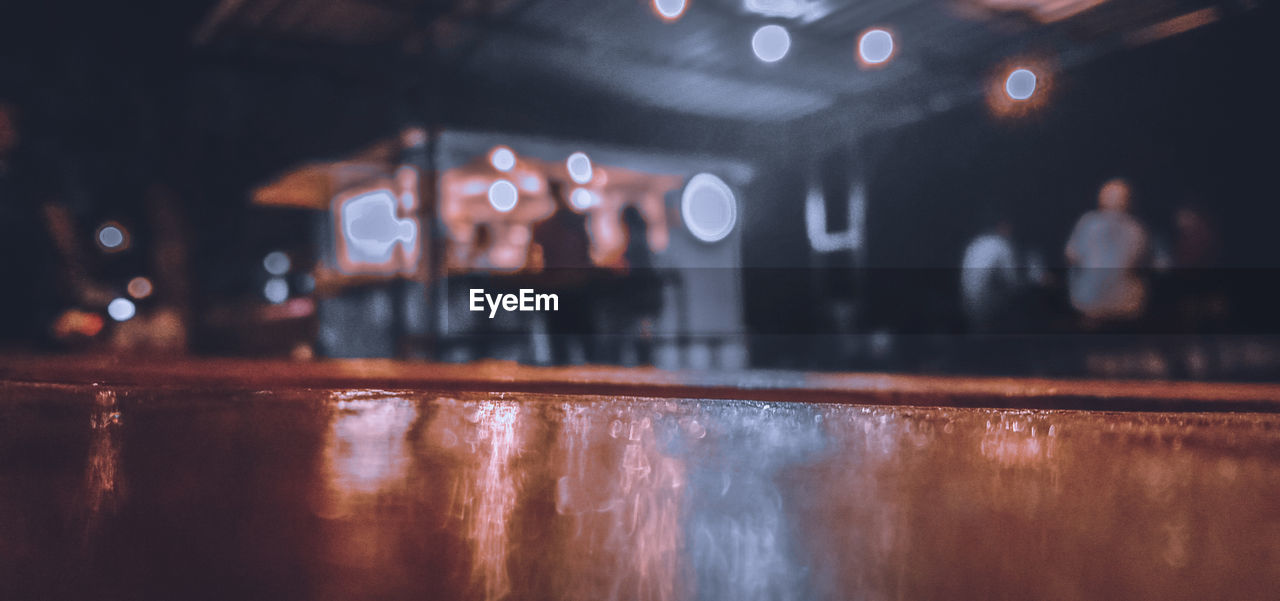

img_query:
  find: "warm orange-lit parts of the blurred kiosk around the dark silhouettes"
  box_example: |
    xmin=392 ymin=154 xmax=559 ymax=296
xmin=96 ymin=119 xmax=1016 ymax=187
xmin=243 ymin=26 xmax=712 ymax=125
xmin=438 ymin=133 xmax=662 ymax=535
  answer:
xmin=253 ymin=133 xmax=684 ymax=277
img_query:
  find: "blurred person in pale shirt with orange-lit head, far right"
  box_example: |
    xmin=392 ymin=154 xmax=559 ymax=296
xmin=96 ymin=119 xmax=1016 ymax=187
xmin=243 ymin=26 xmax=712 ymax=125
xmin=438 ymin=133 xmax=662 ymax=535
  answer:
xmin=1066 ymin=178 xmax=1149 ymax=326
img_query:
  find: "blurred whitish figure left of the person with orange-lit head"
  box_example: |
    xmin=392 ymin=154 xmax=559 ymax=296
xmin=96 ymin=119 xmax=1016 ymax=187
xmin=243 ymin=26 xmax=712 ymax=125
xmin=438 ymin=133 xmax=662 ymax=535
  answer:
xmin=960 ymin=219 xmax=1019 ymax=332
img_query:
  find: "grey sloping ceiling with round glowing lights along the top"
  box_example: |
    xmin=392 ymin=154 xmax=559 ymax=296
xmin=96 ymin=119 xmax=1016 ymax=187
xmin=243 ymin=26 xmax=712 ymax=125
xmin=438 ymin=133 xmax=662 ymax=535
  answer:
xmin=193 ymin=0 xmax=1248 ymax=136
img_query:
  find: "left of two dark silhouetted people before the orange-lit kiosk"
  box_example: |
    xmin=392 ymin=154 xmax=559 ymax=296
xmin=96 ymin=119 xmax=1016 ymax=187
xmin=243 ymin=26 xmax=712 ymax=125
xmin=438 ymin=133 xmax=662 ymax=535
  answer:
xmin=534 ymin=182 xmax=594 ymax=364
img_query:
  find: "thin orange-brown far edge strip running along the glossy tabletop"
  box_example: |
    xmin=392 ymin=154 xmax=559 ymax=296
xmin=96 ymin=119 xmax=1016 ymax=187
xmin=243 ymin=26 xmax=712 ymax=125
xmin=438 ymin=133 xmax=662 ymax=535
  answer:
xmin=0 ymin=355 xmax=1280 ymax=413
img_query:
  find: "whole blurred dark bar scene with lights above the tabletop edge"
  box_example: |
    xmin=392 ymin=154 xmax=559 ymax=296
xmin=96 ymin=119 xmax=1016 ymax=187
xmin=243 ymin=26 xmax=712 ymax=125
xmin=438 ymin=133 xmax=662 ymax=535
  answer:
xmin=0 ymin=0 xmax=1280 ymax=379
